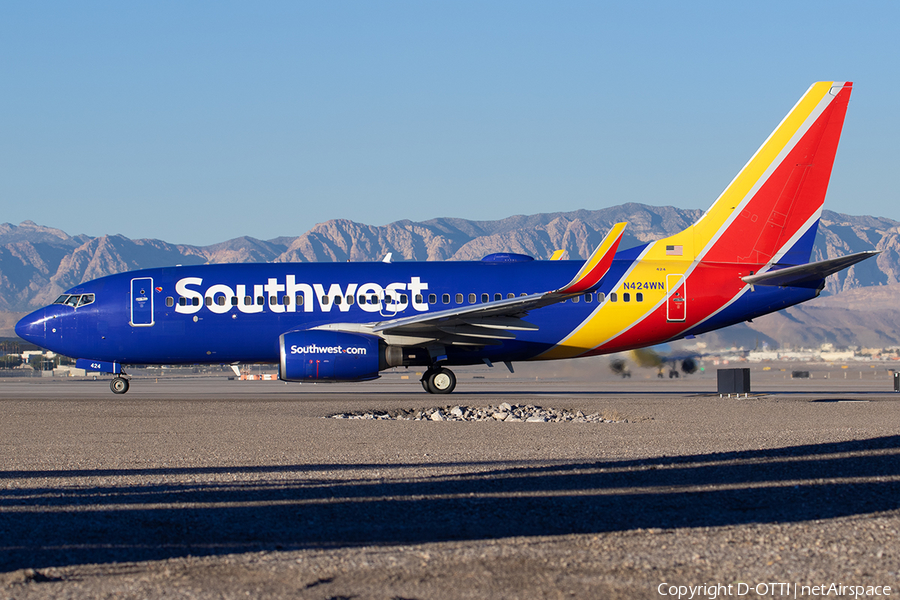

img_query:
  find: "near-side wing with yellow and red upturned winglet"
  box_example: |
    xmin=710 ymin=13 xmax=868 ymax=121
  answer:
xmin=320 ymin=223 xmax=626 ymax=346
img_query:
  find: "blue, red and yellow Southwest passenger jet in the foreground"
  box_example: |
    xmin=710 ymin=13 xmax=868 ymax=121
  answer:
xmin=16 ymin=81 xmax=877 ymax=394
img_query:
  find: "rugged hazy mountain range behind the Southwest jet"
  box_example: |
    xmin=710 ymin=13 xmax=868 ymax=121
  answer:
xmin=0 ymin=203 xmax=900 ymax=346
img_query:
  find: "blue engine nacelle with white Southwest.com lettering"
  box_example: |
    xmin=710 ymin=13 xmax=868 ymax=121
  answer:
xmin=278 ymin=330 xmax=389 ymax=381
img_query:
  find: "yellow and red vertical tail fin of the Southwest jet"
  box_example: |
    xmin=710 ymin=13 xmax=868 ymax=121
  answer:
xmin=688 ymin=81 xmax=853 ymax=264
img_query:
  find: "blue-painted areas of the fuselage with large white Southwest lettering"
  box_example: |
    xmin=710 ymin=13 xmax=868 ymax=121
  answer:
xmin=16 ymin=251 xmax=815 ymax=364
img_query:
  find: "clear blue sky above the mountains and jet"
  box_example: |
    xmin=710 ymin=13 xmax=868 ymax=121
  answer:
xmin=0 ymin=0 xmax=900 ymax=245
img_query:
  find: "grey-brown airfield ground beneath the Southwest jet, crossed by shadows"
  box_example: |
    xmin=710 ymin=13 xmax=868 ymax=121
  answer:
xmin=0 ymin=365 xmax=900 ymax=599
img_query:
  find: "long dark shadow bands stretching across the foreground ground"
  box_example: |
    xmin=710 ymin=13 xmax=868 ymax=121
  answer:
xmin=0 ymin=436 xmax=900 ymax=571
